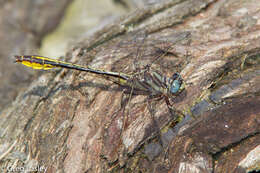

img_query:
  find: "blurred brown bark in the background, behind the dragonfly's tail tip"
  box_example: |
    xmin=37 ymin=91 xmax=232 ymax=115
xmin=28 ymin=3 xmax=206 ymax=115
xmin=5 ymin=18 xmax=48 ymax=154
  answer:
xmin=0 ymin=0 xmax=71 ymax=113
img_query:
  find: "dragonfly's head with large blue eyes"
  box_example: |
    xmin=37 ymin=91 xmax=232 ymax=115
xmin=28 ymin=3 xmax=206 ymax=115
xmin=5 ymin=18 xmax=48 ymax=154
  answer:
xmin=170 ymin=73 xmax=184 ymax=94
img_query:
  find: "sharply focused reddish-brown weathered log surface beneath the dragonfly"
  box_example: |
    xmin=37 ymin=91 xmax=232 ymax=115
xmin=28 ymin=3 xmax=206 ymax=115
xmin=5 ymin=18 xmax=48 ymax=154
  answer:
xmin=0 ymin=0 xmax=260 ymax=173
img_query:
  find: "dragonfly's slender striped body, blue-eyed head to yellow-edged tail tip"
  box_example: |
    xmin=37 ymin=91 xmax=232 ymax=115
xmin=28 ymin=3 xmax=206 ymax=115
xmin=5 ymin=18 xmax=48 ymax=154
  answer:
xmin=15 ymin=55 xmax=184 ymax=100
